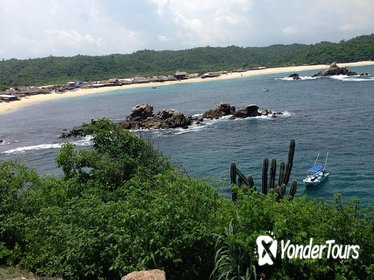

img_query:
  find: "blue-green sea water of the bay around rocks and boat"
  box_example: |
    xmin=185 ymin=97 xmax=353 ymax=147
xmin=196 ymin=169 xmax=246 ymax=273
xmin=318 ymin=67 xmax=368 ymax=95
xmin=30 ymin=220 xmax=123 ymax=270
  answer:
xmin=0 ymin=66 xmax=374 ymax=204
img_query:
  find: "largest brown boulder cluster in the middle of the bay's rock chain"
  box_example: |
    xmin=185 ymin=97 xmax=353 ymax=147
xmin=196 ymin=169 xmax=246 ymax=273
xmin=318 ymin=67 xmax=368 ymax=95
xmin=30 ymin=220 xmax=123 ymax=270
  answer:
xmin=120 ymin=104 xmax=192 ymax=129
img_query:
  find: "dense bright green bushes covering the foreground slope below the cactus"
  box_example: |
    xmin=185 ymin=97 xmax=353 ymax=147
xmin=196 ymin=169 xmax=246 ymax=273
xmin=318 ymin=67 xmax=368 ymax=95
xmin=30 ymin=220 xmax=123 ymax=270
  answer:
xmin=0 ymin=120 xmax=374 ymax=279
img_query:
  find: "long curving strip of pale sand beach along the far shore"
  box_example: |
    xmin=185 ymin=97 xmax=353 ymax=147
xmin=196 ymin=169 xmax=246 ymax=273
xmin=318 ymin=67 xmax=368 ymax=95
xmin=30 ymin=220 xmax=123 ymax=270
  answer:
xmin=0 ymin=61 xmax=374 ymax=115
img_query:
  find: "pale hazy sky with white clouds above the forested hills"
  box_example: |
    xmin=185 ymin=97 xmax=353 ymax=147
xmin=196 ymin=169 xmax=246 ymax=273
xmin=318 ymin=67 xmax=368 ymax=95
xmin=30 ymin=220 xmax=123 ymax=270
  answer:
xmin=0 ymin=0 xmax=374 ymax=59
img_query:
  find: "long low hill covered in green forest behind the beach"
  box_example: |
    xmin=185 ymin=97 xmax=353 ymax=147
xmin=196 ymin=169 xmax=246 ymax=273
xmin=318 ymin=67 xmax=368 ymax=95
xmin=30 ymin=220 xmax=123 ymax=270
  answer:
xmin=0 ymin=34 xmax=374 ymax=88
